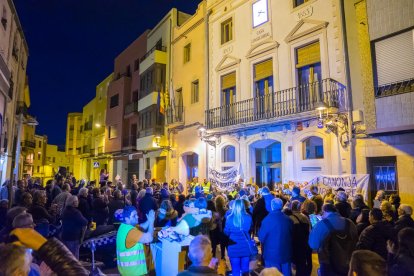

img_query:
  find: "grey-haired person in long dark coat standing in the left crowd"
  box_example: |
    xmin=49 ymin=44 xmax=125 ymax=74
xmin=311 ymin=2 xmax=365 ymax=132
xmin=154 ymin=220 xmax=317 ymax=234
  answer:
xmin=62 ymin=195 xmax=88 ymax=259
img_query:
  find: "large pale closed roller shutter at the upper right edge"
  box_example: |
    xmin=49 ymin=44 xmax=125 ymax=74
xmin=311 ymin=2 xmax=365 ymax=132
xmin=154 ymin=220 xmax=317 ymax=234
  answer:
xmin=375 ymin=30 xmax=414 ymax=86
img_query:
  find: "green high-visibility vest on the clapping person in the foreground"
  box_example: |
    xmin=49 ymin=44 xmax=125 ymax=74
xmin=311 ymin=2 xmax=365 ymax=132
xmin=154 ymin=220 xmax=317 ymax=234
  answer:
xmin=116 ymin=223 xmax=147 ymax=276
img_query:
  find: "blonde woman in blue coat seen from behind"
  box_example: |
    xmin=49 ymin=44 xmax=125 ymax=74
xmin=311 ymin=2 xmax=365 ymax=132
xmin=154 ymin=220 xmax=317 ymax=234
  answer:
xmin=224 ymin=199 xmax=253 ymax=276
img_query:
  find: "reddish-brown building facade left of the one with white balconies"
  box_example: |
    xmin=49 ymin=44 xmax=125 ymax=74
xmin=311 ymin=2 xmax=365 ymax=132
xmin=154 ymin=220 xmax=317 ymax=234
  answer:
xmin=105 ymin=31 xmax=148 ymax=182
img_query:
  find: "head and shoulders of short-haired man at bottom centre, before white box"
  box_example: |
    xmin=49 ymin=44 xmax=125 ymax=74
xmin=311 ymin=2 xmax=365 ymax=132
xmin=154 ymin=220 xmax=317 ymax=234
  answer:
xmin=177 ymin=235 xmax=218 ymax=276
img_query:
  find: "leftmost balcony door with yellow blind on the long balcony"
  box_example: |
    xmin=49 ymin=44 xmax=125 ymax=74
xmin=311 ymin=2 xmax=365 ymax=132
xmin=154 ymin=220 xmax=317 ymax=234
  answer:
xmin=221 ymin=72 xmax=236 ymax=120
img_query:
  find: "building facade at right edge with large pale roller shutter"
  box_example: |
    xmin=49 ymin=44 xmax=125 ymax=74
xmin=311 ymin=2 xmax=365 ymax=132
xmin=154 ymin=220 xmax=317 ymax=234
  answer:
xmin=345 ymin=0 xmax=414 ymax=205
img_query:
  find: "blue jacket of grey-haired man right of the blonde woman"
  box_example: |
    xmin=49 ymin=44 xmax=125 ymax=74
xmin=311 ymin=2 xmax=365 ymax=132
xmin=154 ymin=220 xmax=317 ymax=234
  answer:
xmin=258 ymin=210 xmax=293 ymax=264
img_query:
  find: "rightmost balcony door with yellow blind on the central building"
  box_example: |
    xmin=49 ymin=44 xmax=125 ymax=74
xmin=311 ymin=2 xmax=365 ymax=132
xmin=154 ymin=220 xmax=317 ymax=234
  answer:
xmin=296 ymin=41 xmax=323 ymax=111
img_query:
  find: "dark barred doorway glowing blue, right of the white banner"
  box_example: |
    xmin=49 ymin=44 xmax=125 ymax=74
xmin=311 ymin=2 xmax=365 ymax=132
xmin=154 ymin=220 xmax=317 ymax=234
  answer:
xmin=367 ymin=156 xmax=398 ymax=202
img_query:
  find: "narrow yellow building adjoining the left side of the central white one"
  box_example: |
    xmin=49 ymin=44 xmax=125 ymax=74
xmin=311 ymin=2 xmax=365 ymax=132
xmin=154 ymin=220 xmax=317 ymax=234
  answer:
xmin=167 ymin=2 xmax=208 ymax=187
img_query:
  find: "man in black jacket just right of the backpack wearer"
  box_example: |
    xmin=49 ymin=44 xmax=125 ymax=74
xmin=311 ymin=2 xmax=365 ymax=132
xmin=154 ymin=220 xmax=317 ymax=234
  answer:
xmin=357 ymin=208 xmax=394 ymax=260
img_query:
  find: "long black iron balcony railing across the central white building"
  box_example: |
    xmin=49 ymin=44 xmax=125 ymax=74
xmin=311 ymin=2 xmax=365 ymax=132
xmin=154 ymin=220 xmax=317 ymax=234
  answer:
xmin=206 ymin=79 xmax=346 ymax=129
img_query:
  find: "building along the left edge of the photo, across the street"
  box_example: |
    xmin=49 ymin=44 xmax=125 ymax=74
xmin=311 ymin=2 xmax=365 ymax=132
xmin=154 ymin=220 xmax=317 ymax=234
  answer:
xmin=0 ymin=0 xmax=28 ymax=183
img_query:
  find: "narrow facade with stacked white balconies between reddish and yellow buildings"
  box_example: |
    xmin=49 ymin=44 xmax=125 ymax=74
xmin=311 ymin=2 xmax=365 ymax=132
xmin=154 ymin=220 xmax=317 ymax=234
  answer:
xmin=136 ymin=9 xmax=190 ymax=182
